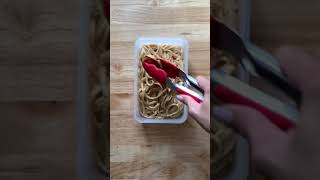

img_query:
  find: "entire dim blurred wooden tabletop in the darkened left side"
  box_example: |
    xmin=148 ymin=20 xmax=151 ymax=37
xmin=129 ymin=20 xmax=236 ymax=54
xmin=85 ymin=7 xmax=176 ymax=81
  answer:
xmin=0 ymin=0 xmax=79 ymax=180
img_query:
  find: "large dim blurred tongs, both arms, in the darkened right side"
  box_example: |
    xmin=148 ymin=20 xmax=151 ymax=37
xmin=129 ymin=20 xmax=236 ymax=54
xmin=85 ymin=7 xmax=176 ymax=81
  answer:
xmin=211 ymin=18 xmax=301 ymax=130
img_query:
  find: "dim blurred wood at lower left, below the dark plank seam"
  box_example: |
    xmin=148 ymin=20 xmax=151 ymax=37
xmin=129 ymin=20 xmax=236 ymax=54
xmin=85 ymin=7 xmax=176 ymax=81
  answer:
xmin=0 ymin=102 xmax=75 ymax=180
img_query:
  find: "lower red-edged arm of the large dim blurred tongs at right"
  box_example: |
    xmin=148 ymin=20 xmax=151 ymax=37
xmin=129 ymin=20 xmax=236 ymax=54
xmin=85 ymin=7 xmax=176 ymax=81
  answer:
xmin=211 ymin=70 xmax=299 ymax=130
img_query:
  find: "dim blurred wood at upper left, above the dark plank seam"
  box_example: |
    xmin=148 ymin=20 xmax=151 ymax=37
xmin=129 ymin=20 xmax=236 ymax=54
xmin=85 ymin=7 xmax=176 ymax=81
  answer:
xmin=0 ymin=0 xmax=79 ymax=101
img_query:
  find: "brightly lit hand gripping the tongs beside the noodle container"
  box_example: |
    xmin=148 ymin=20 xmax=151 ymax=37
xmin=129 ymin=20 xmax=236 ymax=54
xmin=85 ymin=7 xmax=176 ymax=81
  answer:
xmin=177 ymin=76 xmax=210 ymax=132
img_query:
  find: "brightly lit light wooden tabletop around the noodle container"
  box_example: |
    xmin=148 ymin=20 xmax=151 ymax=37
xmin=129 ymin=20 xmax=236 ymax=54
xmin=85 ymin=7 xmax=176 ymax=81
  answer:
xmin=110 ymin=0 xmax=210 ymax=179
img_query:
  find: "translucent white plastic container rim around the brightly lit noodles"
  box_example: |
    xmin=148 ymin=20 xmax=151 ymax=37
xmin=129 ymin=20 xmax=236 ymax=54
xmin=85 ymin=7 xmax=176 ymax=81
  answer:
xmin=133 ymin=37 xmax=189 ymax=124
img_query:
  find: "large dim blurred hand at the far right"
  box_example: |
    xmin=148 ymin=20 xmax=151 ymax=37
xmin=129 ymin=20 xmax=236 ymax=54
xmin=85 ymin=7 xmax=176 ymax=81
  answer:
xmin=213 ymin=48 xmax=320 ymax=180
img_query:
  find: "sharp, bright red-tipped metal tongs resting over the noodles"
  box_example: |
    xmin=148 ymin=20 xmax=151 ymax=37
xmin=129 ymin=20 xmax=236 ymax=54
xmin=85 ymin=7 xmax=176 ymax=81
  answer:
xmin=143 ymin=55 xmax=204 ymax=103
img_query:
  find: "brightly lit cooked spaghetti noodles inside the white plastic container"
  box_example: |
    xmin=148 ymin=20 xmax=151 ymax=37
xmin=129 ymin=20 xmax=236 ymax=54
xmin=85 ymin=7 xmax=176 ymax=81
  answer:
xmin=138 ymin=44 xmax=183 ymax=119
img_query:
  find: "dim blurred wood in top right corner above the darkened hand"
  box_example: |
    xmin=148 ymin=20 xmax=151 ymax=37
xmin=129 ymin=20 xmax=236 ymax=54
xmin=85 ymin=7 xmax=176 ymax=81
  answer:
xmin=252 ymin=0 xmax=320 ymax=52
